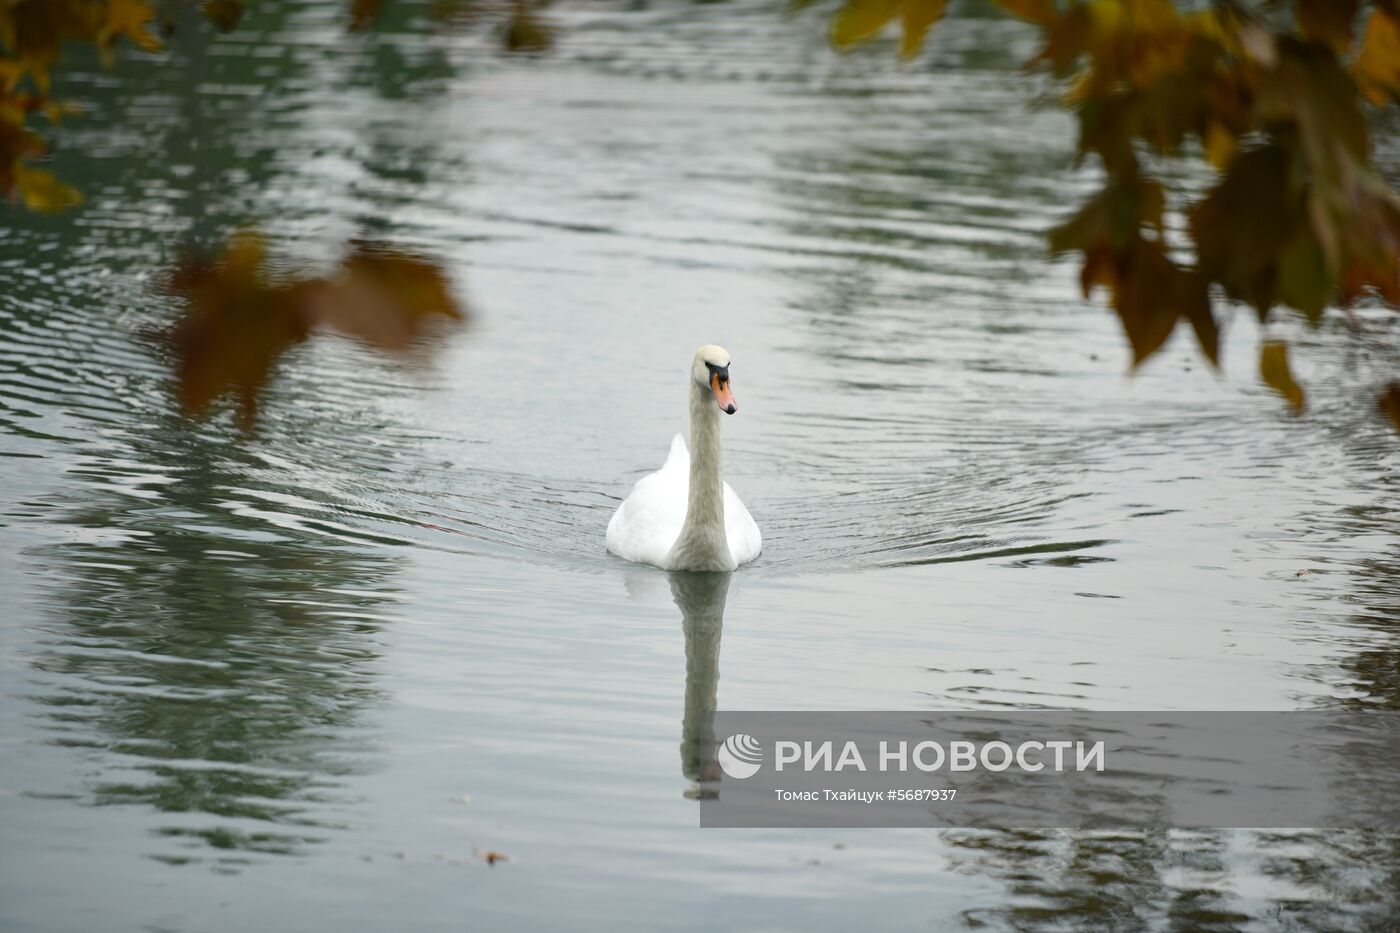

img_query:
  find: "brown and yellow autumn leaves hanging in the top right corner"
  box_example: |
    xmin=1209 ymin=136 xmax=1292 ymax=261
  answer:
xmin=832 ymin=0 xmax=1400 ymax=425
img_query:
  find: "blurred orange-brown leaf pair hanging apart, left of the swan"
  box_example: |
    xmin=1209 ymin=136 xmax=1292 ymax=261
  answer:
xmin=169 ymin=234 xmax=466 ymax=431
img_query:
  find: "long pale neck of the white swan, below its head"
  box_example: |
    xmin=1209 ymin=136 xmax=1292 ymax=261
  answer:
xmin=671 ymin=382 xmax=734 ymax=570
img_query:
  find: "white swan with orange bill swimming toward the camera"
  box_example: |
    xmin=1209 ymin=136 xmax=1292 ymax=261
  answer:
xmin=608 ymin=346 xmax=763 ymax=570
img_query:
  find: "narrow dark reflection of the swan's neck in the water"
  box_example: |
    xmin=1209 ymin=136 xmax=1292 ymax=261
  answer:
xmin=671 ymin=573 xmax=732 ymax=800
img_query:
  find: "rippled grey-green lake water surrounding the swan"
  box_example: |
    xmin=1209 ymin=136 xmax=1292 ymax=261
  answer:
xmin=0 ymin=1 xmax=1400 ymax=933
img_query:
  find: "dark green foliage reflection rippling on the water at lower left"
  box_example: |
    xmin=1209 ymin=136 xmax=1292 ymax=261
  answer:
xmin=27 ymin=420 xmax=392 ymax=852
